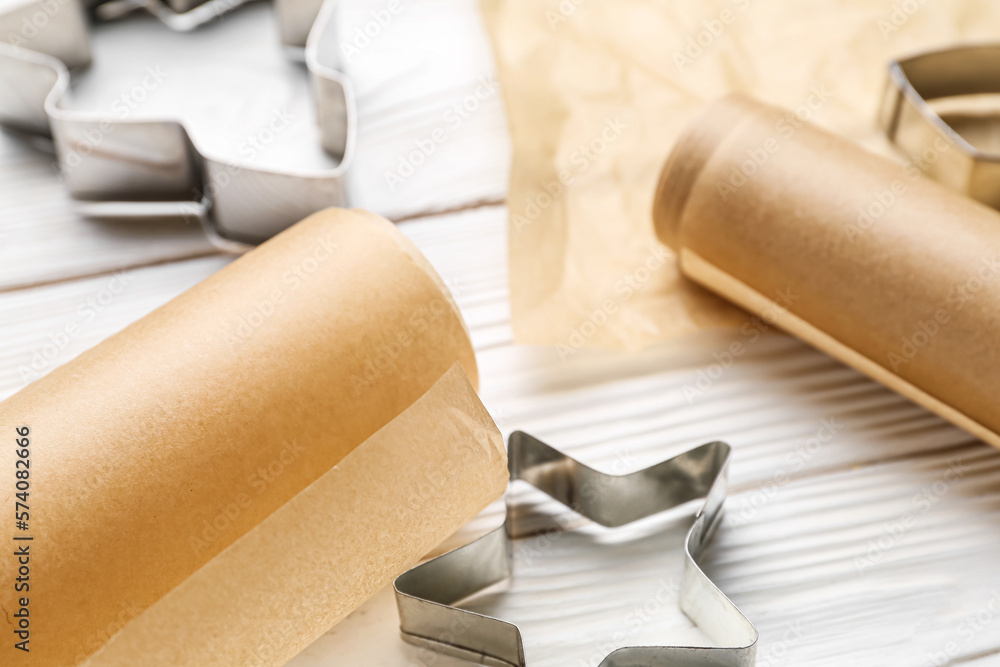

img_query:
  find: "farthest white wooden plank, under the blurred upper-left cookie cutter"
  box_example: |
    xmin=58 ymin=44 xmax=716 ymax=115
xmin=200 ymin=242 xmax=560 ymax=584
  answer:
xmin=0 ymin=0 xmax=510 ymax=290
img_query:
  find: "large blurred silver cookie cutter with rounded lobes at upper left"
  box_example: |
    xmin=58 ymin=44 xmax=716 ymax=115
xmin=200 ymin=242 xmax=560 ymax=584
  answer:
xmin=0 ymin=0 xmax=356 ymax=251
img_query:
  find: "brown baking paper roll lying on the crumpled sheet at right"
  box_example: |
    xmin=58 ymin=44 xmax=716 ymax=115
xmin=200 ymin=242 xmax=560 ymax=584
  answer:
xmin=653 ymin=92 xmax=1000 ymax=446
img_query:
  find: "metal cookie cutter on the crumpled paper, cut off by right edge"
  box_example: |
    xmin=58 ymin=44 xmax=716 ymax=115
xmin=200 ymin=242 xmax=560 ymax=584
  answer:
xmin=879 ymin=45 xmax=1000 ymax=208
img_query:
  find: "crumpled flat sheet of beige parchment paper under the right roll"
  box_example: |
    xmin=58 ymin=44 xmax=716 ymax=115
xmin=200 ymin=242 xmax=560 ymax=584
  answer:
xmin=483 ymin=0 xmax=1000 ymax=354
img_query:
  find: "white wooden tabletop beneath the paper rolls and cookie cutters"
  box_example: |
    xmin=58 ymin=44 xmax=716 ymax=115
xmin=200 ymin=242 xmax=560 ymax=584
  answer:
xmin=0 ymin=0 xmax=1000 ymax=667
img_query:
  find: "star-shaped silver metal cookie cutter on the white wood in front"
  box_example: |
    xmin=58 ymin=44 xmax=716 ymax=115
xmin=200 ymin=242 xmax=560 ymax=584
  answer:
xmin=394 ymin=431 xmax=758 ymax=667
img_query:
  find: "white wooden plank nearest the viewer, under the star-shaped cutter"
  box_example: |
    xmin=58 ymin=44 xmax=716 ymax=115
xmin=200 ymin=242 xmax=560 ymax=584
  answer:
xmin=289 ymin=445 xmax=1000 ymax=667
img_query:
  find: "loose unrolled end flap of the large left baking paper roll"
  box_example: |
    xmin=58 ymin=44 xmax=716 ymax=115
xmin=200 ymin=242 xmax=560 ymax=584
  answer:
xmin=85 ymin=366 xmax=506 ymax=667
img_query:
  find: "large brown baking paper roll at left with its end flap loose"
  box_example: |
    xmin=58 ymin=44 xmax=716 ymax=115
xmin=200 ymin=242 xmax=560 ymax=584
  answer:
xmin=0 ymin=209 xmax=507 ymax=667
